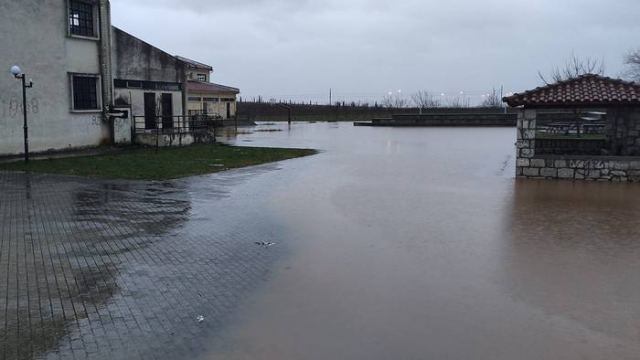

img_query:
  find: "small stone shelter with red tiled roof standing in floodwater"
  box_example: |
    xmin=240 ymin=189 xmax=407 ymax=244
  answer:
xmin=503 ymin=74 xmax=640 ymax=182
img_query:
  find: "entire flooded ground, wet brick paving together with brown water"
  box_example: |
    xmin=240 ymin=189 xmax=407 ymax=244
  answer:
xmin=0 ymin=123 xmax=640 ymax=360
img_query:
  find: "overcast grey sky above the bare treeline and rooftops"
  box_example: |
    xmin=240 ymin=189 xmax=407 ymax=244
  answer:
xmin=111 ymin=0 xmax=640 ymax=102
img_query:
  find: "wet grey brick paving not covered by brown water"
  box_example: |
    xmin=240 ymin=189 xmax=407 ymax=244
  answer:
xmin=0 ymin=168 xmax=283 ymax=359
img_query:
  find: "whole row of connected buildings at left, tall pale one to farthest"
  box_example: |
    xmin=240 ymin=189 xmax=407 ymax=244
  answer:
xmin=0 ymin=0 xmax=239 ymax=156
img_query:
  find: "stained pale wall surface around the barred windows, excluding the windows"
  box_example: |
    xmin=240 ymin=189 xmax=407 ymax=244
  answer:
xmin=0 ymin=0 xmax=109 ymax=155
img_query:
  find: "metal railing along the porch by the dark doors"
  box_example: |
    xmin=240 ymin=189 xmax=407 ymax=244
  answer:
xmin=133 ymin=114 xmax=223 ymax=147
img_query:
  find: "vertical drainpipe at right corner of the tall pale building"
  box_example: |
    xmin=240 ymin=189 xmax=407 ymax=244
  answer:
xmin=100 ymin=0 xmax=115 ymax=145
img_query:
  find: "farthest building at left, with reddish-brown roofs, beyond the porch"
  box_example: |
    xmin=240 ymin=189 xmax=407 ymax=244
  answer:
xmin=177 ymin=56 xmax=240 ymax=119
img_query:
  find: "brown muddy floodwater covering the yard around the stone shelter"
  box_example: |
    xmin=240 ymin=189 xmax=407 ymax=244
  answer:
xmin=203 ymin=123 xmax=640 ymax=360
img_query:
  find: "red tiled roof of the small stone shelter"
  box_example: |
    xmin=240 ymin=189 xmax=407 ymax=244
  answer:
xmin=502 ymin=74 xmax=640 ymax=107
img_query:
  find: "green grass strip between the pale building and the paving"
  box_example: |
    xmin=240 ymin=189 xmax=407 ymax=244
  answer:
xmin=0 ymin=144 xmax=317 ymax=180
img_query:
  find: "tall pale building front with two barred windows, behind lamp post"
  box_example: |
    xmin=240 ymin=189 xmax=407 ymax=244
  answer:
xmin=0 ymin=0 xmax=113 ymax=155
